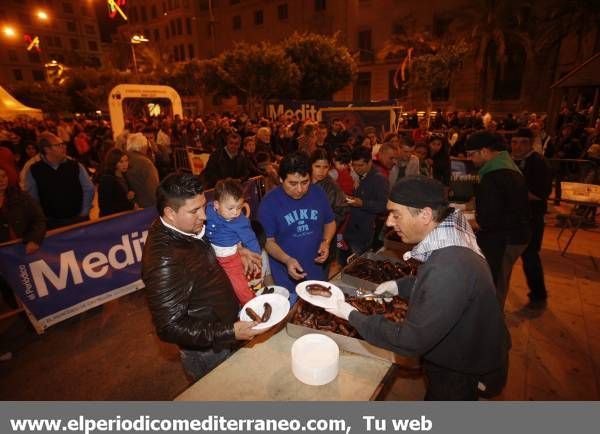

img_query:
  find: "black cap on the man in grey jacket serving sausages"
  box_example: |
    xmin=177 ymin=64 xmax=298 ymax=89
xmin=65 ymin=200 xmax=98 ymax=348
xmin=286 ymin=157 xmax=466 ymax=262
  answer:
xmin=390 ymin=175 xmax=448 ymax=209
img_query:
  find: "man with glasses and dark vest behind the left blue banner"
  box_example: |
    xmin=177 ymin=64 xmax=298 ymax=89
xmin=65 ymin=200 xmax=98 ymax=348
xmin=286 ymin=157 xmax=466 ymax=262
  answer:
xmin=24 ymin=131 xmax=94 ymax=229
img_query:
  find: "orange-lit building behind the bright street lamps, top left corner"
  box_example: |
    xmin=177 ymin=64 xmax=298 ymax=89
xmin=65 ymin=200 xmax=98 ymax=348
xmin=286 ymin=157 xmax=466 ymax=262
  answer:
xmin=0 ymin=0 xmax=103 ymax=85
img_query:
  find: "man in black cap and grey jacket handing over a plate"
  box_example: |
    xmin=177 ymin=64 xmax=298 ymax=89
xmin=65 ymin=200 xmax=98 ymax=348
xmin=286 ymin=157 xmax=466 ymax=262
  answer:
xmin=328 ymin=176 xmax=510 ymax=400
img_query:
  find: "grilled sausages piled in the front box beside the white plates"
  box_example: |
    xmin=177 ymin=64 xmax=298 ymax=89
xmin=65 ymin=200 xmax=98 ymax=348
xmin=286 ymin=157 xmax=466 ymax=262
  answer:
xmin=291 ymin=295 xmax=408 ymax=338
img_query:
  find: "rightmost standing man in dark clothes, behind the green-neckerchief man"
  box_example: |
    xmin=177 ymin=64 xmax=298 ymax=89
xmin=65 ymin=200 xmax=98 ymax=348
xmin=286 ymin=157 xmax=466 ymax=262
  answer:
xmin=511 ymin=128 xmax=552 ymax=308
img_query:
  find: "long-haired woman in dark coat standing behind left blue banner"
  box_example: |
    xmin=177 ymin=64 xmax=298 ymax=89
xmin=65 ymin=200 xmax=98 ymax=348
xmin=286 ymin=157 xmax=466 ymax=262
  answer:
xmin=98 ymin=148 xmax=135 ymax=217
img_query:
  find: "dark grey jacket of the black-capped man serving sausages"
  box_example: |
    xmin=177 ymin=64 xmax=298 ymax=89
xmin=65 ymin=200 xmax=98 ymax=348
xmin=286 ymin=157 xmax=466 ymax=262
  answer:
xmin=349 ymin=246 xmax=510 ymax=375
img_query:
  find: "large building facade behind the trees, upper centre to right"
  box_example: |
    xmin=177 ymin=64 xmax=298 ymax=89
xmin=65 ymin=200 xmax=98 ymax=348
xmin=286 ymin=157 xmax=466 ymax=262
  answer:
xmin=122 ymin=0 xmax=600 ymax=113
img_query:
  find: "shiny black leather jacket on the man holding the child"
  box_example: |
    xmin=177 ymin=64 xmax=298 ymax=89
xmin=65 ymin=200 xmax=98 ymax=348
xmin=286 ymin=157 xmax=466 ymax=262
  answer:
xmin=142 ymin=219 xmax=240 ymax=351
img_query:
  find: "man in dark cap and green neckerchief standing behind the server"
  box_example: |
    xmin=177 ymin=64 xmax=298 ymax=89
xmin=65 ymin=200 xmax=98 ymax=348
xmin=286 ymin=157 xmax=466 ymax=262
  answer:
xmin=466 ymin=131 xmax=530 ymax=310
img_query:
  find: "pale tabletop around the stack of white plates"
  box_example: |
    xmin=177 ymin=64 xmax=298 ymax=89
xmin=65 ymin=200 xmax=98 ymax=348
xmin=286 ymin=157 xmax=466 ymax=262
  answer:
xmin=175 ymin=323 xmax=392 ymax=401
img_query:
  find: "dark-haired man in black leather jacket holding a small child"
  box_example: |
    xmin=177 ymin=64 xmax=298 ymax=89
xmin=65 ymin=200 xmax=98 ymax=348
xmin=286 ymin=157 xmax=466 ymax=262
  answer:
xmin=142 ymin=173 xmax=264 ymax=381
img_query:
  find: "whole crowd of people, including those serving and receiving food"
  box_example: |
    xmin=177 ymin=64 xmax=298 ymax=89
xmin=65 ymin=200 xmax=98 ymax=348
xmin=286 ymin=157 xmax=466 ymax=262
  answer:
xmin=0 ymin=104 xmax=600 ymax=399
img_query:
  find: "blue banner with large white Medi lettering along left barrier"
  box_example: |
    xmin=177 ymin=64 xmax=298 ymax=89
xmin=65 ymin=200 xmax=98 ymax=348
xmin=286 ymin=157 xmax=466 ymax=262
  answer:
xmin=0 ymin=208 xmax=157 ymax=328
